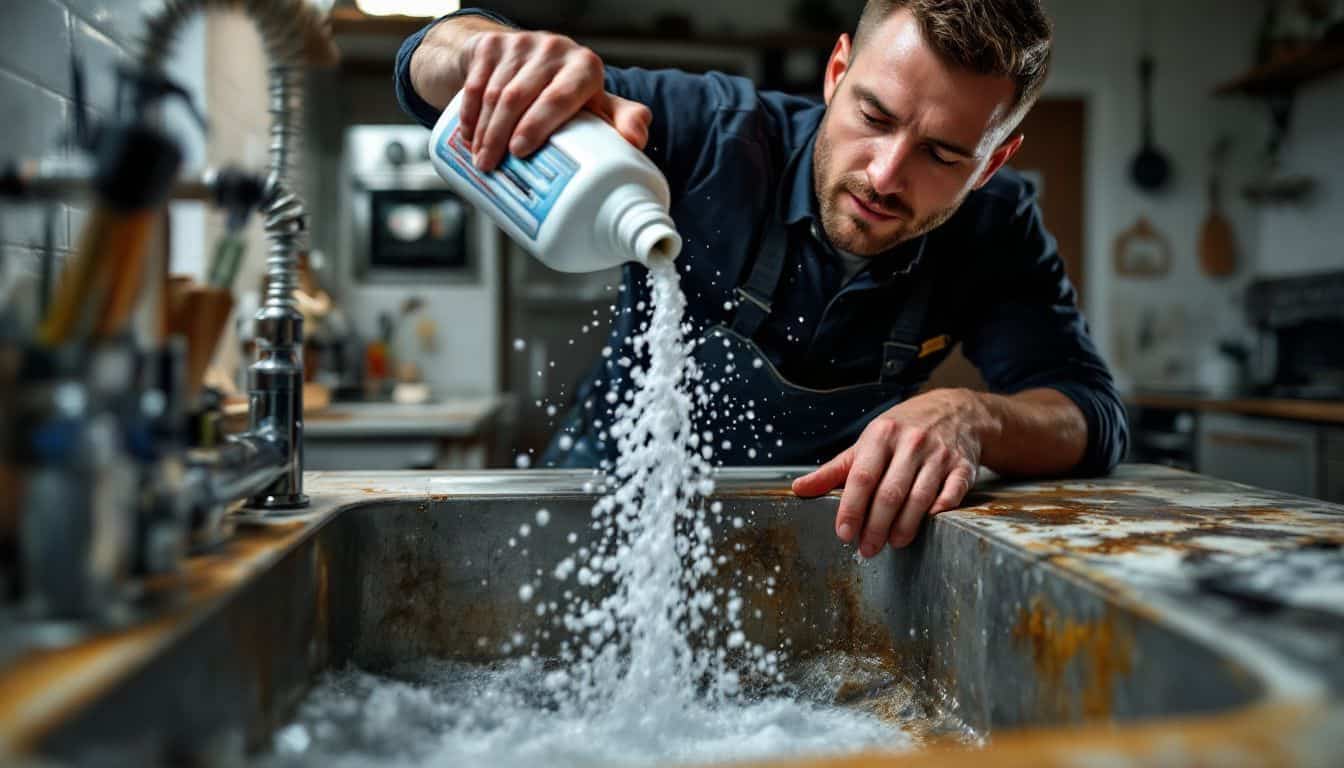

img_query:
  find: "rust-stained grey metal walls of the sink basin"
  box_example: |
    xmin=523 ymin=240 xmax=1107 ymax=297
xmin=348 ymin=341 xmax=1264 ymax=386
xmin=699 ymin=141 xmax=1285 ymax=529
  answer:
xmin=13 ymin=471 xmax=1344 ymax=756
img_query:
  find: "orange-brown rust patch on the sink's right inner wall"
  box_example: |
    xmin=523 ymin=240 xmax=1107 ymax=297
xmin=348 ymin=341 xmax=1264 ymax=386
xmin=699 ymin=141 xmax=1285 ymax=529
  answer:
xmin=1012 ymin=597 xmax=1134 ymax=720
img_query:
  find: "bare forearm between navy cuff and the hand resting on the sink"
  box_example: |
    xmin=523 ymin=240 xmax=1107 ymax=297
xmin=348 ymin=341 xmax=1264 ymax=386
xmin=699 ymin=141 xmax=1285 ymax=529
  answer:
xmin=978 ymin=389 xmax=1087 ymax=475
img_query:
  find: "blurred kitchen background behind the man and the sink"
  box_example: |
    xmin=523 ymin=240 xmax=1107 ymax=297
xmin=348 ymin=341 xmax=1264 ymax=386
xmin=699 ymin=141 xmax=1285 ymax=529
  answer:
xmin=0 ymin=0 xmax=1344 ymax=500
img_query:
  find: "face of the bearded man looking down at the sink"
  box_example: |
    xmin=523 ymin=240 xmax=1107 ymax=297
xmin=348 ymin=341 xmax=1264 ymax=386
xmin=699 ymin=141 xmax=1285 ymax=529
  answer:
xmin=813 ymin=11 xmax=1021 ymax=256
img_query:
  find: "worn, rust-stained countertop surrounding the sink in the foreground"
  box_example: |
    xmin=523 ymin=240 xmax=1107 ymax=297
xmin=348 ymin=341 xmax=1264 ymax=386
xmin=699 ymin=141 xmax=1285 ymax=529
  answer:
xmin=0 ymin=465 xmax=1344 ymax=765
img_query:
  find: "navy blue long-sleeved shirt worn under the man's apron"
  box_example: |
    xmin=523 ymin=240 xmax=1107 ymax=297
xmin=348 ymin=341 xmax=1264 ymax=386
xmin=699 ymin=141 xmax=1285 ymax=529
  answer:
xmin=396 ymin=11 xmax=1128 ymax=473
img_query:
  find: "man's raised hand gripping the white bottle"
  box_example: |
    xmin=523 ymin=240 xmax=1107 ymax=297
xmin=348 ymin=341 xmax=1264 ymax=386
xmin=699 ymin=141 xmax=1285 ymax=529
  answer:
xmin=411 ymin=17 xmax=652 ymax=171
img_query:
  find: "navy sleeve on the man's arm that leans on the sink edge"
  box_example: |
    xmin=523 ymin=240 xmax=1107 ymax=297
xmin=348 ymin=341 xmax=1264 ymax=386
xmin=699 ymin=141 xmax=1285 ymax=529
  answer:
xmin=964 ymin=186 xmax=1129 ymax=475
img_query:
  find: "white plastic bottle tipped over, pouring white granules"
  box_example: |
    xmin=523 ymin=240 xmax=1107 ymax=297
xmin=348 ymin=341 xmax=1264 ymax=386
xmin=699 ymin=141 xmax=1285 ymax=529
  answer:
xmin=430 ymin=93 xmax=681 ymax=272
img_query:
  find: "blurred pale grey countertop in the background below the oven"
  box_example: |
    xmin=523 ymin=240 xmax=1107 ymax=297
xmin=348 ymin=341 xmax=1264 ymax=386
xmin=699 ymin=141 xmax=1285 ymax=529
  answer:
xmin=304 ymin=395 xmax=504 ymax=440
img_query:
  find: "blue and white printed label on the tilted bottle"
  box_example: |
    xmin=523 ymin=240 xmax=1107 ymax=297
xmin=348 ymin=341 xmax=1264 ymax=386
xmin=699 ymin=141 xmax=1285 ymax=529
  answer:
xmin=434 ymin=117 xmax=579 ymax=239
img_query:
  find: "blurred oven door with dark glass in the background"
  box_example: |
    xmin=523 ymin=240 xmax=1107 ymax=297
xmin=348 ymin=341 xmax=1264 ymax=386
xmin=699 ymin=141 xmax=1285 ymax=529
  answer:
xmin=351 ymin=176 xmax=481 ymax=284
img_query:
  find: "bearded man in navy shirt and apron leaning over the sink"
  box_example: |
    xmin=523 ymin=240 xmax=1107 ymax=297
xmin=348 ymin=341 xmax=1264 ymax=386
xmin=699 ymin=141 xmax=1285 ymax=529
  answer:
xmin=396 ymin=0 xmax=1128 ymax=557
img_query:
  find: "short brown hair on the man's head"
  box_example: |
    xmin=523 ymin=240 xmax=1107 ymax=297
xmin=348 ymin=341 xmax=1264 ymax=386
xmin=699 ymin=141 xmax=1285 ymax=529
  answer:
xmin=853 ymin=0 xmax=1052 ymax=129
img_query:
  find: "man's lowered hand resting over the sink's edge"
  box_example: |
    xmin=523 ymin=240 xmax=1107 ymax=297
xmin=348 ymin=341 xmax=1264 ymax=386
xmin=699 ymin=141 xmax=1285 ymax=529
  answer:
xmin=793 ymin=389 xmax=996 ymax=557
